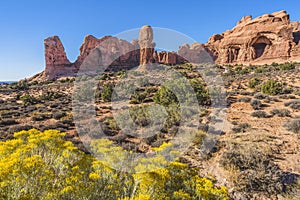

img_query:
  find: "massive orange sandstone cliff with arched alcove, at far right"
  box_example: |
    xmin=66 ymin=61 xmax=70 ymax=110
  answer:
xmin=206 ymin=11 xmax=300 ymax=64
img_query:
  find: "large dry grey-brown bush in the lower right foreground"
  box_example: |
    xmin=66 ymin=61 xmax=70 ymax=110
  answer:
xmin=221 ymin=145 xmax=285 ymax=195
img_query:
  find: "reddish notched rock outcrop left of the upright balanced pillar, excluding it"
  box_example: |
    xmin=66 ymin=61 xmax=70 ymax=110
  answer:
xmin=44 ymin=35 xmax=140 ymax=80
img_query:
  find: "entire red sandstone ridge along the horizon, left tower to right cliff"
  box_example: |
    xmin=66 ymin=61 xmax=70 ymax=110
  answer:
xmin=41 ymin=11 xmax=300 ymax=80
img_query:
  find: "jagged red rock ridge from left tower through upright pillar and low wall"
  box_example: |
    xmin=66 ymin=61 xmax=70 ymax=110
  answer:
xmin=42 ymin=25 xmax=186 ymax=80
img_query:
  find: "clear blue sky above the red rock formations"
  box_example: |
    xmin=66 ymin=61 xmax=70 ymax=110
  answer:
xmin=0 ymin=0 xmax=300 ymax=80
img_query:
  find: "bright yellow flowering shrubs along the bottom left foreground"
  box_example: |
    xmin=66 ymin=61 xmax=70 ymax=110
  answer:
xmin=0 ymin=129 xmax=228 ymax=200
